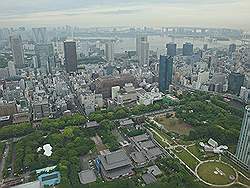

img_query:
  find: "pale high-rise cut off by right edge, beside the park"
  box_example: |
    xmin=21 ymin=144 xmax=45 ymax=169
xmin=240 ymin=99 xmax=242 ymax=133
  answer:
xmin=236 ymin=105 xmax=250 ymax=171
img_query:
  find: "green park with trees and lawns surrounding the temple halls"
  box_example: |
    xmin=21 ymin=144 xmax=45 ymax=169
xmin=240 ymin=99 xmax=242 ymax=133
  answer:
xmin=0 ymin=90 xmax=250 ymax=188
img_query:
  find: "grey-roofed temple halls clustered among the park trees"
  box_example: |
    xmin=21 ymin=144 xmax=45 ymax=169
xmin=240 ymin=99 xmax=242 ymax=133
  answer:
xmin=96 ymin=119 xmax=166 ymax=184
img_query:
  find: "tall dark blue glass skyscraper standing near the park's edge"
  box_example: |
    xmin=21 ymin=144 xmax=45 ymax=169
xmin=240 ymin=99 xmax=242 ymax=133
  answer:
xmin=159 ymin=55 xmax=173 ymax=92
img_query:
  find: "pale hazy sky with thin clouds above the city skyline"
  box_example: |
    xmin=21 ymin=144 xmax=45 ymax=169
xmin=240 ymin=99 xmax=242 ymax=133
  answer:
xmin=0 ymin=0 xmax=250 ymax=31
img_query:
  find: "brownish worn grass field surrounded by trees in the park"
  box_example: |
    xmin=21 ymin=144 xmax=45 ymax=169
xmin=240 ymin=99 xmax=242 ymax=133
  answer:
xmin=154 ymin=116 xmax=192 ymax=135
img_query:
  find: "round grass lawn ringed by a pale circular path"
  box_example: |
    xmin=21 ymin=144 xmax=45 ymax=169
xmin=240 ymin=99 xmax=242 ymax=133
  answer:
xmin=198 ymin=162 xmax=236 ymax=185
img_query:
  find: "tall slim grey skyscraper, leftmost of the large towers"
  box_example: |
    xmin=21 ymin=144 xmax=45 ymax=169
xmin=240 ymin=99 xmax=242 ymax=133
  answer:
xmin=10 ymin=35 xmax=24 ymax=68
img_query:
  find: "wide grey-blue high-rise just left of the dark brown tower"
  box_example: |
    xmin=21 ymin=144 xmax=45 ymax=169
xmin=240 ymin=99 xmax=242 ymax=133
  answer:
xmin=35 ymin=44 xmax=53 ymax=73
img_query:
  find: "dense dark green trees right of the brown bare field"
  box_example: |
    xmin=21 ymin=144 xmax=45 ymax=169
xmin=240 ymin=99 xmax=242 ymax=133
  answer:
xmin=176 ymin=92 xmax=243 ymax=145
